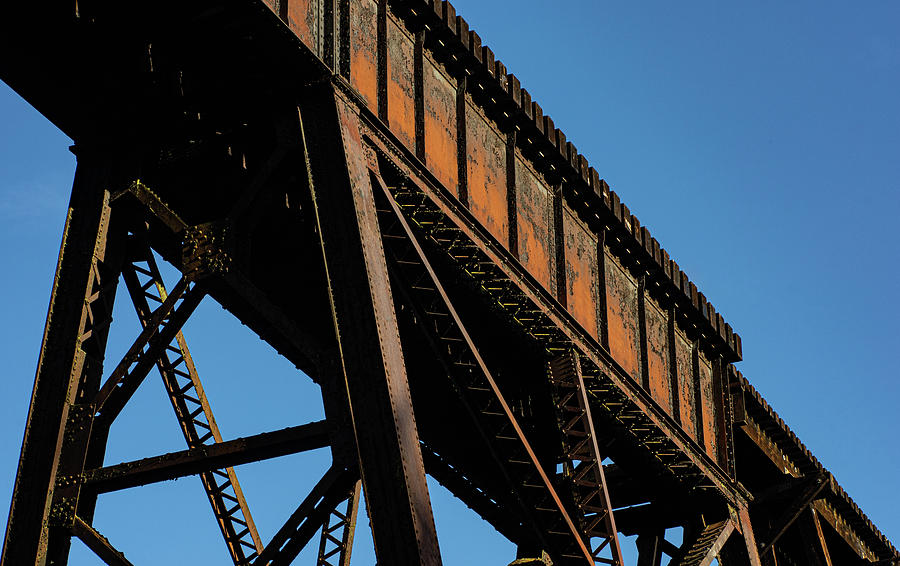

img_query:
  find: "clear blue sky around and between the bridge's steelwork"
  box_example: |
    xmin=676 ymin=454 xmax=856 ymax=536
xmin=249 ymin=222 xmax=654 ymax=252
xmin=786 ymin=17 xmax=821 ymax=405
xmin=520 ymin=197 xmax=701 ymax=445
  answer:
xmin=0 ymin=0 xmax=900 ymax=565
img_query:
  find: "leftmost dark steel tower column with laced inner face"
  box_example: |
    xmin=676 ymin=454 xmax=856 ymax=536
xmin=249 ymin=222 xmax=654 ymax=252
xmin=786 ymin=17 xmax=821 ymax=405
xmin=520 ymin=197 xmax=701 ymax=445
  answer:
xmin=2 ymin=150 xmax=121 ymax=566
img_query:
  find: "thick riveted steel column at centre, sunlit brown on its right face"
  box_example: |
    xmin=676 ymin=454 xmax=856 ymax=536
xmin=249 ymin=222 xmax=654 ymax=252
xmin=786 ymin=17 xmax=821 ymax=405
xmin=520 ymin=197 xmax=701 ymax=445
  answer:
xmin=301 ymin=85 xmax=441 ymax=565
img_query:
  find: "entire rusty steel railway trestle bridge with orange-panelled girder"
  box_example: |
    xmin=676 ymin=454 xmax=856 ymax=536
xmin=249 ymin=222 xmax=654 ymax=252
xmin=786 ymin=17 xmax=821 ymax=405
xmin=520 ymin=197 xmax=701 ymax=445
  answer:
xmin=0 ymin=0 xmax=900 ymax=566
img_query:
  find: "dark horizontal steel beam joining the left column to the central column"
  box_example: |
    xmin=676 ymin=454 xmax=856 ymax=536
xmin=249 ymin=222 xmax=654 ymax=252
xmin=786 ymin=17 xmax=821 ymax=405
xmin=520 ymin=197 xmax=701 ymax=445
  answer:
xmin=84 ymin=421 xmax=329 ymax=493
